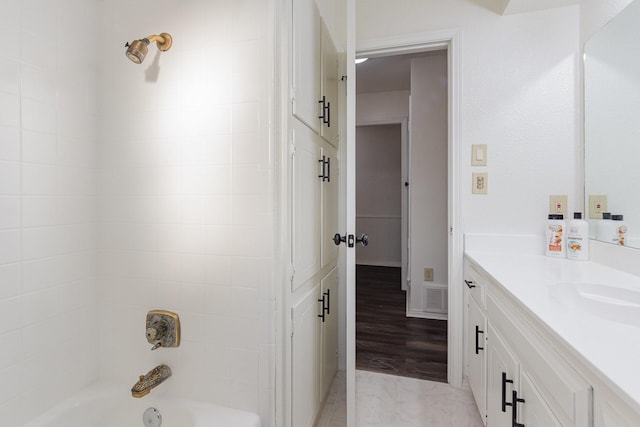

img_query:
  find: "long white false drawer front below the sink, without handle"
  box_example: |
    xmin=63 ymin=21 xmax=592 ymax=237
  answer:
xmin=487 ymin=292 xmax=593 ymax=427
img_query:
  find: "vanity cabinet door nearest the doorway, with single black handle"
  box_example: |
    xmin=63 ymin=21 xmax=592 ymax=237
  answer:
xmin=466 ymin=298 xmax=487 ymax=423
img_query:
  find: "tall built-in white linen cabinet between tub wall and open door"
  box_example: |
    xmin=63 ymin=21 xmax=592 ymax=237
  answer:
xmin=286 ymin=0 xmax=341 ymax=427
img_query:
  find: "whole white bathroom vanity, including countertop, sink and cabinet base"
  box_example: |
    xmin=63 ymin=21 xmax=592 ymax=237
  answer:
xmin=463 ymin=236 xmax=640 ymax=427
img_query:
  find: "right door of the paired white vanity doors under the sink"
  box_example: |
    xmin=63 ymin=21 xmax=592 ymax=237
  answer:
xmin=516 ymin=370 xmax=562 ymax=427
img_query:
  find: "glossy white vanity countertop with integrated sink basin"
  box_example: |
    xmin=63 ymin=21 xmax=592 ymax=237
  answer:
xmin=465 ymin=249 xmax=640 ymax=408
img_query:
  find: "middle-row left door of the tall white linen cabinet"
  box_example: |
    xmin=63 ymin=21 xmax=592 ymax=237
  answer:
xmin=291 ymin=120 xmax=322 ymax=291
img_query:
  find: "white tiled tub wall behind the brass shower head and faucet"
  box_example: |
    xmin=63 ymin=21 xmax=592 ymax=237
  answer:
xmin=99 ymin=0 xmax=275 ymax=425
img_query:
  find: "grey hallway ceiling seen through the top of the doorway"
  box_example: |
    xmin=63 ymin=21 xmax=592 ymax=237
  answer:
xmin=356 ymin=50 xmax=447 ymax=93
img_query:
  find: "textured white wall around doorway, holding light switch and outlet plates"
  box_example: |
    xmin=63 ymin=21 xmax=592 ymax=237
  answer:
xmin=357 ymin=0 xmax=582 ymax=234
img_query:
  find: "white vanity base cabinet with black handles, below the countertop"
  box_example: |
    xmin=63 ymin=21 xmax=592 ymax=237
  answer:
xmin=465 ymin=263 xmax=593 ymax=427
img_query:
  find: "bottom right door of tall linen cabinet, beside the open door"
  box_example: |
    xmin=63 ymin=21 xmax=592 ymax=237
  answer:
xmin=320 ymin=268 xmax=338 ymax=400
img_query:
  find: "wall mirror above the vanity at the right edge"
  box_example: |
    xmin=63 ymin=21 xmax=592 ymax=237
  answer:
xmin=584 ymin=0 xmax=640 ymax=248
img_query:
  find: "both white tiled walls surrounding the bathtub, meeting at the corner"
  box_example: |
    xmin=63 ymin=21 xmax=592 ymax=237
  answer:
xmin=0 ymin=0 xmax=275 ymax=426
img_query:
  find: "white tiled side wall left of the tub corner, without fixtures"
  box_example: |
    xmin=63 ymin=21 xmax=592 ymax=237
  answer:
xmin=0 ymin=1 xmax=100 ymax=426
